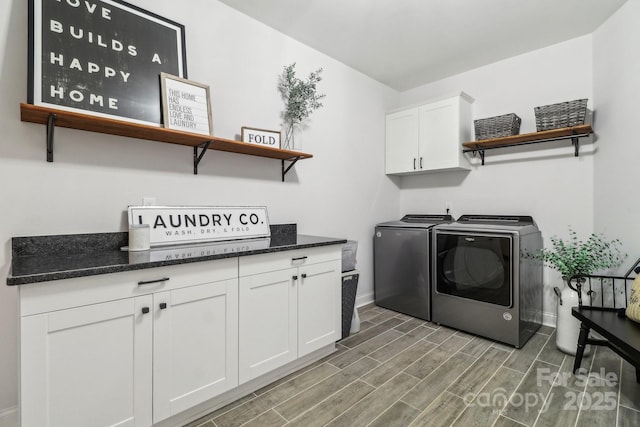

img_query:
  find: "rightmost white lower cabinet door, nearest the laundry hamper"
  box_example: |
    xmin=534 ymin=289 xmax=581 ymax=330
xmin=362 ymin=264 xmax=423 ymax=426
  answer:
xmin=298 ymin=261 xmax=342 ymax=357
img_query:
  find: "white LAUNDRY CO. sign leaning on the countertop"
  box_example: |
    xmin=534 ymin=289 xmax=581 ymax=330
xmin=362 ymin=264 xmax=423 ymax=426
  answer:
xmin=129 ymin=206 xmax=271 ymax=246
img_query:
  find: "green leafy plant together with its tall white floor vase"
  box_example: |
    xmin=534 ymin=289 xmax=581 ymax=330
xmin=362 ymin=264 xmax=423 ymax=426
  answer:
xmin=529 ymin=227 xmax=626 ymax=355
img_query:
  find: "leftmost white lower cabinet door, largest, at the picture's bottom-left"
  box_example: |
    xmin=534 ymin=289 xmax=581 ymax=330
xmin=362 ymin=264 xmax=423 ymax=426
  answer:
xmin=20 ymin=296 xmax=152 ymax=427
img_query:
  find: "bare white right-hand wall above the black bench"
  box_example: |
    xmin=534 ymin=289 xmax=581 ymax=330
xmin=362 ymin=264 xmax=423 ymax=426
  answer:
xmin=593 ymin=0 xmax=640 ymax=260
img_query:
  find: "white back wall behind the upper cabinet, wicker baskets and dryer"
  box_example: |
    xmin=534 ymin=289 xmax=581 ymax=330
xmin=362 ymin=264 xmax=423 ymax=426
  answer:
xmin=392 ymin=36 xmax=597 ymax=323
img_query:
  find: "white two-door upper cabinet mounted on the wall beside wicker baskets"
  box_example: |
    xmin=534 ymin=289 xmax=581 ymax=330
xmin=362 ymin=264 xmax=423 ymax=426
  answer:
xmin=386 ymin=93 xmax=473 ymax=175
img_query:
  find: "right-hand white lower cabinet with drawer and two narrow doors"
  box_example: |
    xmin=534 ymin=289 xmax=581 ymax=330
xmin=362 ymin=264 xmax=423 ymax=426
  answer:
xmin=239 ymin=246 xmax=342 ymax=384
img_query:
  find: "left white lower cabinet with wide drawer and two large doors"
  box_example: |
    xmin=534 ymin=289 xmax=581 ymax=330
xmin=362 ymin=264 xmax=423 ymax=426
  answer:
xmin=20 ymin=260 xmax=238 ymax=427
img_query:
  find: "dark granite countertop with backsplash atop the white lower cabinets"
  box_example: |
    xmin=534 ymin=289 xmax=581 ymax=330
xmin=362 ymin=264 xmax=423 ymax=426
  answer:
xmin=7 ymin=224 xmax=346 ymax=286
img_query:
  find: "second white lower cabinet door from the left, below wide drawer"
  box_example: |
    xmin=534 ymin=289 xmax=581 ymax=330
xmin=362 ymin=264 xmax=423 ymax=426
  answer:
xmin=153 ymin=279 xmax=238 ymax=422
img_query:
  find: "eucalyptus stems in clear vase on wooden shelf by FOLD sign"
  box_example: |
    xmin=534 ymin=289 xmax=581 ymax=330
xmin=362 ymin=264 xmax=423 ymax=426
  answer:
xmin=278 ymin=62 xmax=325 ymax=149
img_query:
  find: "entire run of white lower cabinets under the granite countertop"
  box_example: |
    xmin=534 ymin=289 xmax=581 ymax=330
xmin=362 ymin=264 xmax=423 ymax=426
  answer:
xmin=19 ymin=245 xmax=342 ymax=427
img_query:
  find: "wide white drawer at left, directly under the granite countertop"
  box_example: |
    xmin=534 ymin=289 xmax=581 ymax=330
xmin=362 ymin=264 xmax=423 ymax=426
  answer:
xmin=19 ymin=258 xmax=238 ymax=316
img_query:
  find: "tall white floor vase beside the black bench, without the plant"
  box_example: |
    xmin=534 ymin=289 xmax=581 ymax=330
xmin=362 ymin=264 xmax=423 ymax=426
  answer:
xmin=554 ymin=281 xmax=591 ymax=356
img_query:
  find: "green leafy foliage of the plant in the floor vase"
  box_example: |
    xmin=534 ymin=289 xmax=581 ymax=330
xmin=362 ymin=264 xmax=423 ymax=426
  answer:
xmin=531 ymin=227 xmax=626 ymax=281
